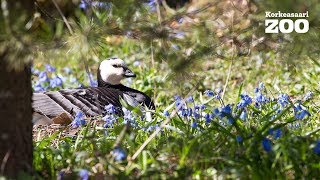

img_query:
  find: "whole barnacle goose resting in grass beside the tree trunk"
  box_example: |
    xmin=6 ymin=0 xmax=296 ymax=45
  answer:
xmin=32 ymin=58 xmax=155 ymax=124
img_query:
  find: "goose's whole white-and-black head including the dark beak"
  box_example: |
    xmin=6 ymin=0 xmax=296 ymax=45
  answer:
xmin=98 ymin=58 xmax=136 ymax=87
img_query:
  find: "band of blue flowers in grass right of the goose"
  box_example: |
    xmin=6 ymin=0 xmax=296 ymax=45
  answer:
xmin=169 ymin=83 xmax=312 ymax=152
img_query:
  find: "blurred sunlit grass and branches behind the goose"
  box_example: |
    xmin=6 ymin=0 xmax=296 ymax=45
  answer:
xmin=0 ymin=0 xmax=320 ymax=102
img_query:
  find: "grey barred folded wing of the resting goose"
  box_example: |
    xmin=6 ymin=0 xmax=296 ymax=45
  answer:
xmin=32 ymin=87 xmax=123 ymax=118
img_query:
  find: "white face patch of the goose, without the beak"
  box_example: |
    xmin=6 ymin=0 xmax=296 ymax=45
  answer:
xmin=99 ymin=58 xmax=127 ymax=85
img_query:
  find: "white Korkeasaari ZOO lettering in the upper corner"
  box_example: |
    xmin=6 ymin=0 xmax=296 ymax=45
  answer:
xmin=264 ymin=11 xmax=309 ymax=34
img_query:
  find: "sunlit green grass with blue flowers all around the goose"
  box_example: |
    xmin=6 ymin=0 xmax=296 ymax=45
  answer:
xmin=28 ymin=1 xmax=320 ymax=179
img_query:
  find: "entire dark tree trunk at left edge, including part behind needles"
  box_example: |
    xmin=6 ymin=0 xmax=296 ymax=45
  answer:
xmin=0 ymin=0 xmax=34 ymax=178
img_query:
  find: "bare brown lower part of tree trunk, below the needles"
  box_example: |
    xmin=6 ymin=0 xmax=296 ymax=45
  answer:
xmin=0 ymin=53 xmax=33 ymax=177
